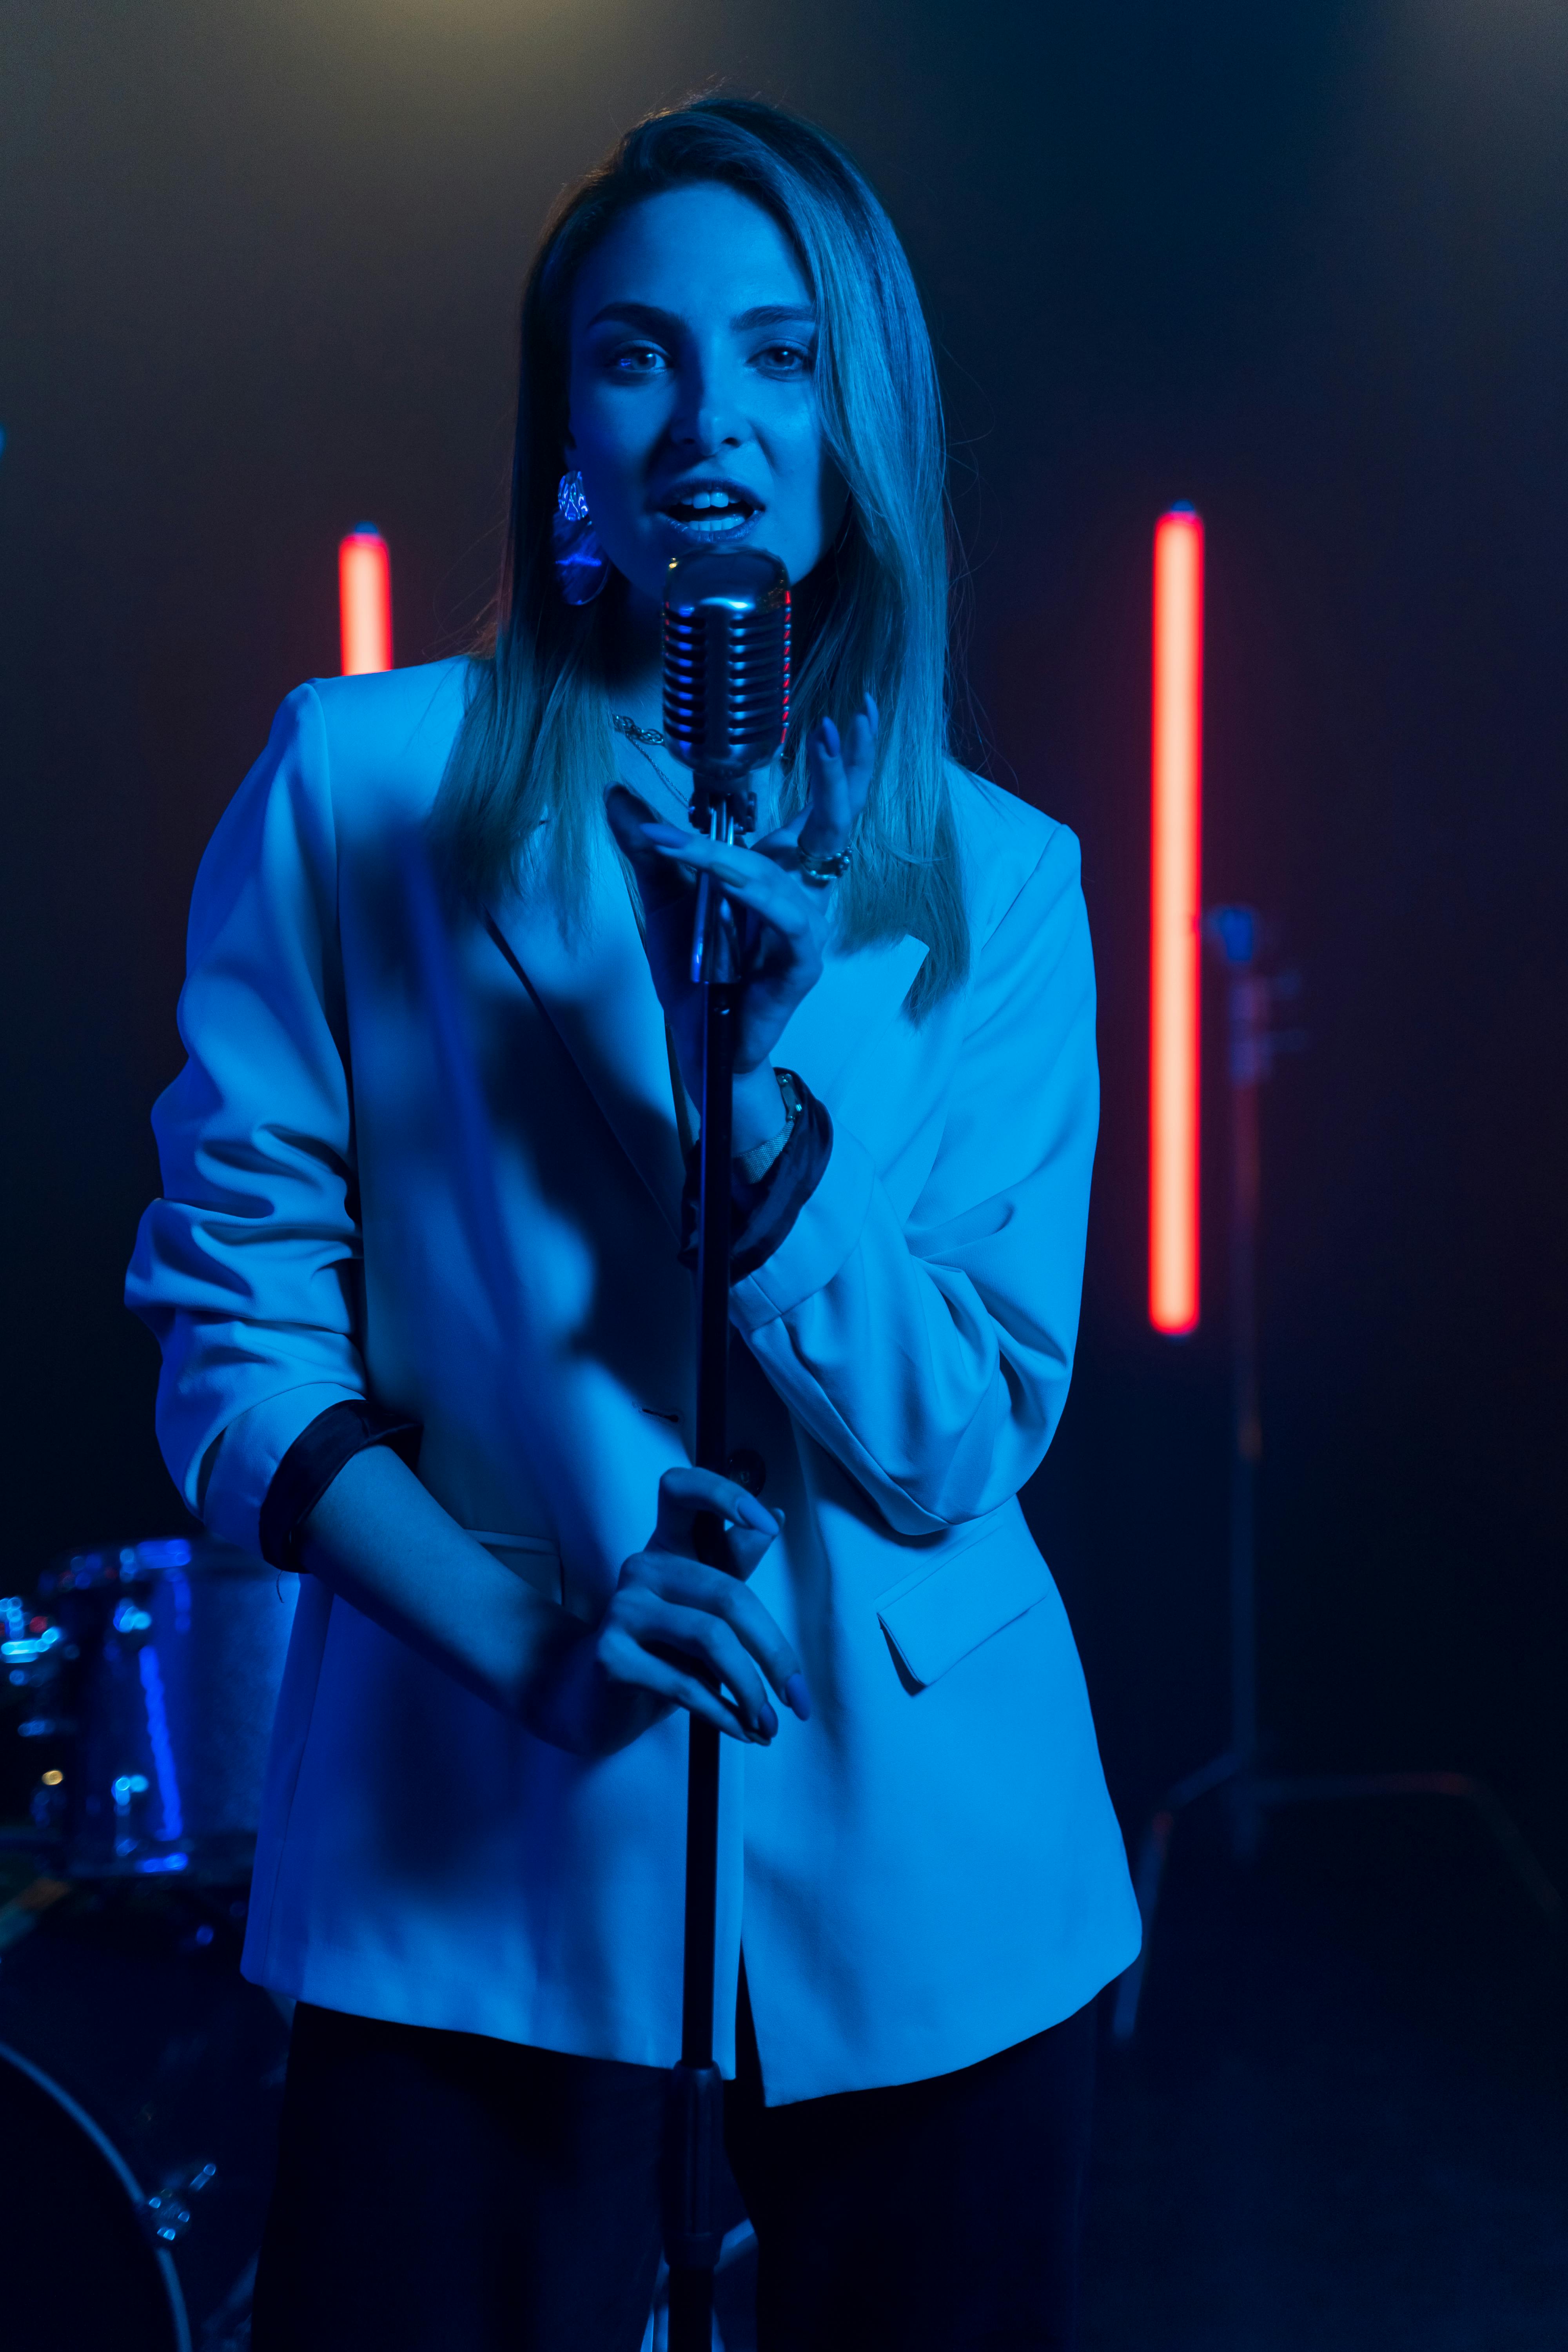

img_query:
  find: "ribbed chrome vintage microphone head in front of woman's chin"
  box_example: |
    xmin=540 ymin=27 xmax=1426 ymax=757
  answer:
xmin=665 ymin=548 xmax=790 ymax=783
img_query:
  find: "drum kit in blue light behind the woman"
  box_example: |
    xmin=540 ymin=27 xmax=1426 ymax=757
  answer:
xmin=0 ymin=1536 xmax=296 ymax=2352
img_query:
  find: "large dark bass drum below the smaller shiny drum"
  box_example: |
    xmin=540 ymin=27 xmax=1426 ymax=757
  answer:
xmin=0 ymin=1863 xmax=287 ymax=2352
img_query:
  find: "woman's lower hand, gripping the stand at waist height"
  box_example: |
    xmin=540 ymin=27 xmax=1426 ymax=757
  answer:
xmin=522 ymin=1470 xmax=811 ymax=1757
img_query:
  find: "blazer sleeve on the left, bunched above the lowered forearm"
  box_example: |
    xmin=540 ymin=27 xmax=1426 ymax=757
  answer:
xmin=125 ymin=687 xmax=367 ymax=1552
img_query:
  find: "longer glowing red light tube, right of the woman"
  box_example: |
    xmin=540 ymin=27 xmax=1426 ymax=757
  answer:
xmin=1150 ymin=506 xmax=1203 ymax=1336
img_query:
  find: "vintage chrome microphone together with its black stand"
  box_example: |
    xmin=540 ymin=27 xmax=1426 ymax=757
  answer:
xmin=663 ymin=548 xmax=790 ymax=2352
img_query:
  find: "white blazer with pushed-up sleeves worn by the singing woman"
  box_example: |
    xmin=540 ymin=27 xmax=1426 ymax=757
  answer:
xmin=127 ymin=661 xmax=1138 ymax=2103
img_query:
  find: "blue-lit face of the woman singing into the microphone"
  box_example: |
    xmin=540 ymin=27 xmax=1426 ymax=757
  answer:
xmin=566 ymin=183 xmax=849 ymax=602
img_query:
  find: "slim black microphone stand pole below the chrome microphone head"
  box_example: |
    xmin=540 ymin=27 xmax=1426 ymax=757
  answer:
xmin=663 ymin=769 xmax=750 ymax=2352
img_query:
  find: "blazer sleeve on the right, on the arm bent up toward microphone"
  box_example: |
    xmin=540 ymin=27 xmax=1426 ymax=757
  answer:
xmin=731 ymin=826 xmax=1100 ymax=1536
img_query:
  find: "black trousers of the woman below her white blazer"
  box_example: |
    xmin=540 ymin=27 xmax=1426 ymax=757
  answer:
xmin=252 ymin=2002 xmax=1093 ymax=2352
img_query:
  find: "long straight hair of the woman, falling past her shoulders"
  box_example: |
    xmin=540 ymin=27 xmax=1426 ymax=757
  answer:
xmin=432 ymin=96 xmax=969 ymax=1016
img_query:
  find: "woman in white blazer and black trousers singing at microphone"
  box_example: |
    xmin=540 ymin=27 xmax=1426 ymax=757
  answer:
xmin=129 ymin=99 xmax=1138 ymax=2352
